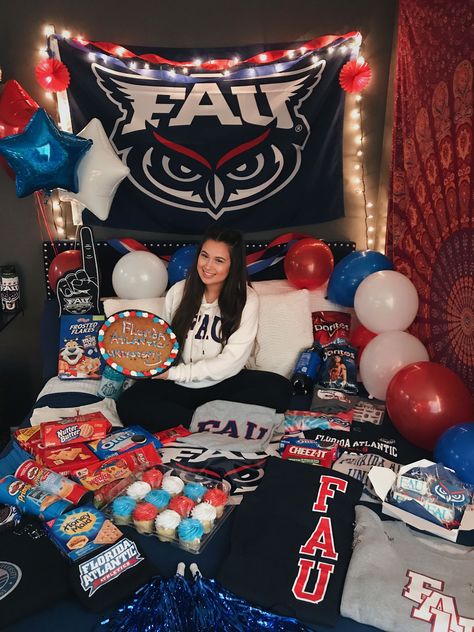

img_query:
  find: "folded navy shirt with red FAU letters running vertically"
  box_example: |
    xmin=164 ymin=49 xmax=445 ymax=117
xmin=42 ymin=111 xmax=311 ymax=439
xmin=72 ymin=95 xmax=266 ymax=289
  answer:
xmin=218 ymin=457 xmax=362 ymax=625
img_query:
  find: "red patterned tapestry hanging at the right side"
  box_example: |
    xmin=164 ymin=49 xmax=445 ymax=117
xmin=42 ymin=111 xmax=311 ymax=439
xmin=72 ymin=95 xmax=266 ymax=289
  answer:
xmin=387 ymin=0 xmax=474 ymax=391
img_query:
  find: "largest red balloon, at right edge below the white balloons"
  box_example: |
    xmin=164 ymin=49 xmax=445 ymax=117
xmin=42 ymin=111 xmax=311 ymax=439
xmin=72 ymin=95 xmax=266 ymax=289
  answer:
xmin=385 ymin=362 xmax=474 ymax=450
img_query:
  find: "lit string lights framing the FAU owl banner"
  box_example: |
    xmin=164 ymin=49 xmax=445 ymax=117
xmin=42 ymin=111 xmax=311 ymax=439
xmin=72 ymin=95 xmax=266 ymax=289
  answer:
xmin=32 ymin=25 xmax=386 ymax=252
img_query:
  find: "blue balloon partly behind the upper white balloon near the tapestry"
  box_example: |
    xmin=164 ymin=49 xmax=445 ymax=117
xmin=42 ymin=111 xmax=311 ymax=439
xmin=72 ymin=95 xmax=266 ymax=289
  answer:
xmin=327 ymin=250 xmax=393 ymax=307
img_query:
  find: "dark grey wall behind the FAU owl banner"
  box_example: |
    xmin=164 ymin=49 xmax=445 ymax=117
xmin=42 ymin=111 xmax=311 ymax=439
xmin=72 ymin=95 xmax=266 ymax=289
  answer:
xmin=0 ymin=0 xmax=396 ymax=425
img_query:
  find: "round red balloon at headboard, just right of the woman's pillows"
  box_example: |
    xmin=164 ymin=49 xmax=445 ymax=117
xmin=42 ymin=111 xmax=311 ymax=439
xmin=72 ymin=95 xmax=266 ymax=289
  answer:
xmin=284 ymin=237 xmax=334 ymax=290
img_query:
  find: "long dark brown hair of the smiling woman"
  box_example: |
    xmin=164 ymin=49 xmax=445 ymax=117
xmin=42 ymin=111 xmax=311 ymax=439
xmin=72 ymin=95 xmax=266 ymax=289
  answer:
xmin=171 ymin=226 xmax=249 ymax=357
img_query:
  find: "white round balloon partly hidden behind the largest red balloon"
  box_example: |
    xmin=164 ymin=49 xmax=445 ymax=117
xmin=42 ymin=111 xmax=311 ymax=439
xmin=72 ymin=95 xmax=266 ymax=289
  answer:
xmin=359 ymin=331 xmax=429 ymax=400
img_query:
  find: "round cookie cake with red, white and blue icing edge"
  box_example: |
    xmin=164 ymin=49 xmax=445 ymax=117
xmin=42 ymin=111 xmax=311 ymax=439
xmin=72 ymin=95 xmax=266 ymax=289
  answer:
xmin=97 ymin=310 xmax=179 ymax=378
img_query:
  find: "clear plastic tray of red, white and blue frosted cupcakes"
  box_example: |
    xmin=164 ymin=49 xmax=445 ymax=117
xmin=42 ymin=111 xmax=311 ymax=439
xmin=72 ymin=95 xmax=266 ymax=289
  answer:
xmin=103 ymin=464 xmax=233 ymax=553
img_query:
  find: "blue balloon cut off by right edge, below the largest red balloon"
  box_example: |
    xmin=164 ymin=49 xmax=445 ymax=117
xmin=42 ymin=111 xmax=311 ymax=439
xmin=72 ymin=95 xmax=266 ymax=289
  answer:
xmin=434 ymin=421 xmax=474 ymax=485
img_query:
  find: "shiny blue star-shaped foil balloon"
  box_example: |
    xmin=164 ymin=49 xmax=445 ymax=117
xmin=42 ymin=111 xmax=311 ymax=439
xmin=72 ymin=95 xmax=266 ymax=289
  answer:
xmin=0 ymin=109 xmax=92 ymax=197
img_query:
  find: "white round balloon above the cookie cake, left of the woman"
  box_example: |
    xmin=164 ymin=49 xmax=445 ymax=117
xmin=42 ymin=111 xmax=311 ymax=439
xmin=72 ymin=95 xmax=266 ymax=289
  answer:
xmin=112 ymin=250 xmax=168 ymax=298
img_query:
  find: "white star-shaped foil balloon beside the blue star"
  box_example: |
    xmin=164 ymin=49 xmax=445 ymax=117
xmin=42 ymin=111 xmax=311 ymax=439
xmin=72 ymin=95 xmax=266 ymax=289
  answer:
xmin=60 ymin=119 xmax=130 ymax=221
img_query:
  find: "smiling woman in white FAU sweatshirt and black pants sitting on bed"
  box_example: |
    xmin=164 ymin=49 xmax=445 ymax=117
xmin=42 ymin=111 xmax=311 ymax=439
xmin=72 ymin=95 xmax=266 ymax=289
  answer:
xmin=117 ymin=226 xmax=291 ymax=432
